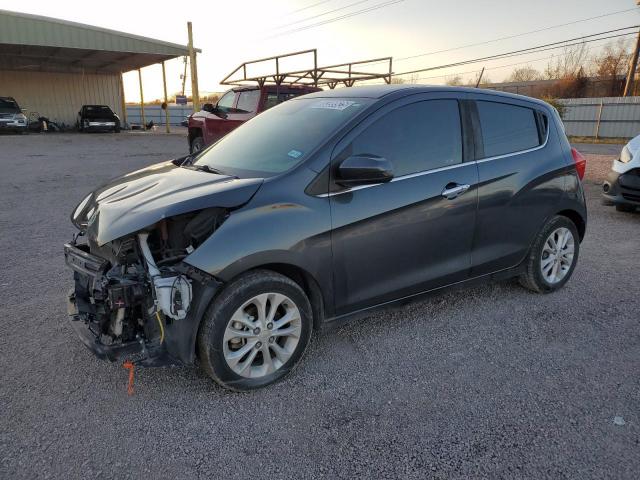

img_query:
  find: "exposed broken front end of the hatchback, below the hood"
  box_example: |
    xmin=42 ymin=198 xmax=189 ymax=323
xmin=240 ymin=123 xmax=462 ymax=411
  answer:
xmin=64 ymin=208 xmax=228 ymax=366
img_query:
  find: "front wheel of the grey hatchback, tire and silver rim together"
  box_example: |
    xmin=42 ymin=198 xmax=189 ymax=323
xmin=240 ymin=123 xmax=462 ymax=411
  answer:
xmin=198 ymin=270 xmax=312 ymax=391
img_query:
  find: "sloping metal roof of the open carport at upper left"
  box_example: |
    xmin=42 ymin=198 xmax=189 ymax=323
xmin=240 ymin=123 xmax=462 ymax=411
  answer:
xmin=0 ymin=10 xmax=200 ymax=74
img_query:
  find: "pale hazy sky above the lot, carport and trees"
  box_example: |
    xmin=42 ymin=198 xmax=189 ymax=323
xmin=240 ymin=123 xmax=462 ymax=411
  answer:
xmin=0 ymin=0 xmax=640 ymax=101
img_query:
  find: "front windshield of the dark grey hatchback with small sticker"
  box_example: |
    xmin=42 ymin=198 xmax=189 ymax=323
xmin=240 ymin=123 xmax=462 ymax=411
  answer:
xmin=194 ymin=98 xmax=371 ymax=178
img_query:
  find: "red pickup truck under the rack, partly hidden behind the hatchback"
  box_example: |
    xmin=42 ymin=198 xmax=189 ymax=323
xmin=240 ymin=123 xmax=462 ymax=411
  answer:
xmin=188 ymin=85 xmax=321 ymax=153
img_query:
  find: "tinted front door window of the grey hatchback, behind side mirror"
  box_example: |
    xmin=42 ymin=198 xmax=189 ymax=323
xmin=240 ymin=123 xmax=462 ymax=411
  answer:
xmin=351 ymin=100 xmax=462 ymax=177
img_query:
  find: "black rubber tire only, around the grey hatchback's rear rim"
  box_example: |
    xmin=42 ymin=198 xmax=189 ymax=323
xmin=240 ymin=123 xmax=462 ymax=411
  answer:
xmin=519 ymin=215 xmax=580 ymax=293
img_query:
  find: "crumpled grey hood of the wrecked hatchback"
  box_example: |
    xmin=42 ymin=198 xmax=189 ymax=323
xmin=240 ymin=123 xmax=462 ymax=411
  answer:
xmin=71 ymin=162 xmax=263 ymax=245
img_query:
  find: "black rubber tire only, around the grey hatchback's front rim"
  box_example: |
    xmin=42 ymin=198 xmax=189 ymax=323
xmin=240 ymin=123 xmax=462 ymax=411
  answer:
xmin=198 ymin=270 xmax=313 ymax=391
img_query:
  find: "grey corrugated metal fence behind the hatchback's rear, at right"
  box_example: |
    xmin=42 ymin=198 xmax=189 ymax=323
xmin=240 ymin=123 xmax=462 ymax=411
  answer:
xmin=560 ymin=97 xmax=640 ymax=138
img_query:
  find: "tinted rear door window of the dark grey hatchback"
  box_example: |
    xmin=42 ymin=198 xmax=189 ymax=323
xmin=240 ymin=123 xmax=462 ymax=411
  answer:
xmin=476 ymin=101 xmax=541 ymax=158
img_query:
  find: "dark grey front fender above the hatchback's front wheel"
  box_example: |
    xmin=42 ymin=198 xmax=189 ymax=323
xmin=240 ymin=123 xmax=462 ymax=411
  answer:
xmin=184 ymin=172 xmax=333 ymax=316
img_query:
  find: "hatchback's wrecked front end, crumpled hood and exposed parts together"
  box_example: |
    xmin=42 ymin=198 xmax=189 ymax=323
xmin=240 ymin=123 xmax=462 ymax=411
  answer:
xmin=64 ymin=159 xmax=262 ymax=366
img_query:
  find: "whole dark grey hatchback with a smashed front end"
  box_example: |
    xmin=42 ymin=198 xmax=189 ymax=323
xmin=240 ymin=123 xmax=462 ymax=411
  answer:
xmin=65 ymin=86 xmax=587 ymax=390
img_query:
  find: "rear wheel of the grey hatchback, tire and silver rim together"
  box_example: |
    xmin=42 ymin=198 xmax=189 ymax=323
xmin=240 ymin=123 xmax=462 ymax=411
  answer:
xmin=520 ymin=215 xmax=580 ymax=293
